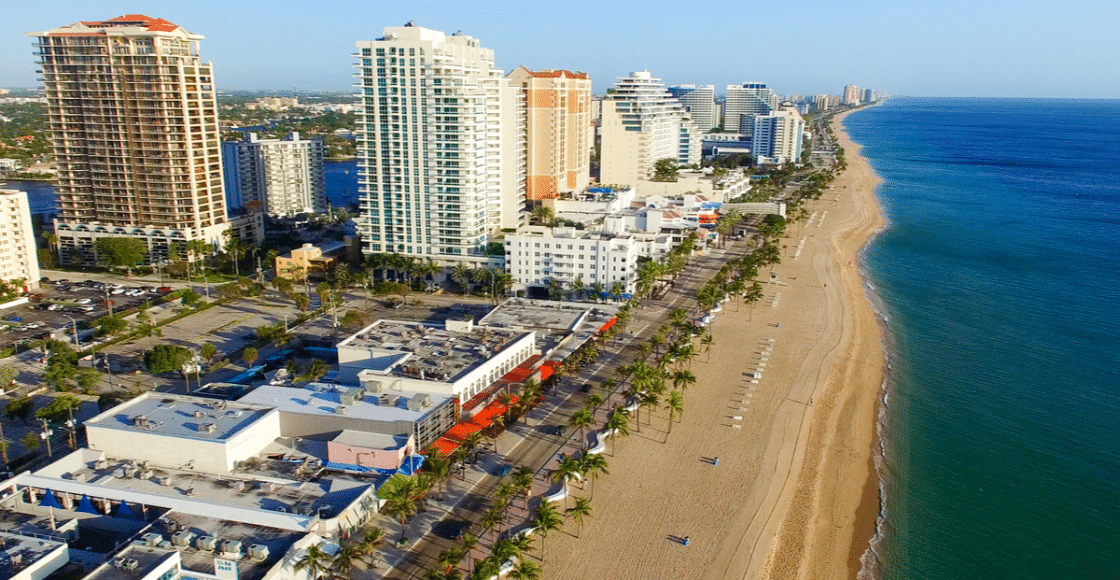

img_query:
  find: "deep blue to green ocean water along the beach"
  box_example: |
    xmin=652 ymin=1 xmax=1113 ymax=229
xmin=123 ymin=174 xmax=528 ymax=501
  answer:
xmin=844 ymin=99 xmax=1120 ymax=580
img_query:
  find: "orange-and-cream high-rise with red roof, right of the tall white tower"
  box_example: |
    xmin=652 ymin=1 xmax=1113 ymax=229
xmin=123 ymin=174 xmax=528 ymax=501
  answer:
xmin=508 ymin=66 xmax=595 ymax=200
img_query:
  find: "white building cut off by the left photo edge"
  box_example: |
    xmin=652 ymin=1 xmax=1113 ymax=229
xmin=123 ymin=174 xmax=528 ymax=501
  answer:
xmin=0 ymin=189 xmax=39 ymax=290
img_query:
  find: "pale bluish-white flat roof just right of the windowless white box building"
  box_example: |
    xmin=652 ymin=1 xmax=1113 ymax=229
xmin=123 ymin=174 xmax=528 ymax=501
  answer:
xmin=241 ymin=383 xmax=452 ymax=422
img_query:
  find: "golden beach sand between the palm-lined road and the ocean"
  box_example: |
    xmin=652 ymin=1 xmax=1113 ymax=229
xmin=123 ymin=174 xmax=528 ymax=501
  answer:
xmin=542 ymin=110 xmax=884 ymax=580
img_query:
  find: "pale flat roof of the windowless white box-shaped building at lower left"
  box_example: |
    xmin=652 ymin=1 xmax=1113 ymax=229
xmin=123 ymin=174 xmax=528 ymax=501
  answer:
xmin=85 ymin=393 xmax=271 ymax=441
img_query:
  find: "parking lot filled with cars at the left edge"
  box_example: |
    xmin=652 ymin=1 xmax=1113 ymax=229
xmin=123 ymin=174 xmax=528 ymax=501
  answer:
xmin=0 ymin=280 xmax=170 ymax=348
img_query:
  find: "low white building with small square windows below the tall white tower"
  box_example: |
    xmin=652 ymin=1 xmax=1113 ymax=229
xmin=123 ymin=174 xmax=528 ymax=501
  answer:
xmin=505 ymin=226 xmax=672 ymax=293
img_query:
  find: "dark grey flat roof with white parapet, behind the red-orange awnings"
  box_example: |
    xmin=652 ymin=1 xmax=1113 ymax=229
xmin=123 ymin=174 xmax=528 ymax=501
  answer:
xmin=333 ymin=320 xmax=525 ymax=385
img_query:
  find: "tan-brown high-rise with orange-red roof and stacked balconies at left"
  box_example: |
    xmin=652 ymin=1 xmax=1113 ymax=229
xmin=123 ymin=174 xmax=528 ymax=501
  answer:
xmin=28 ymin=15 xmax=230 ymax=263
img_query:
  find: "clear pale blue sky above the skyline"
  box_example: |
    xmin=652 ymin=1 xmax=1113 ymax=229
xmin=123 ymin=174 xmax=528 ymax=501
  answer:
xmin=0 ymin=0 xmax=1120 ymax=99
